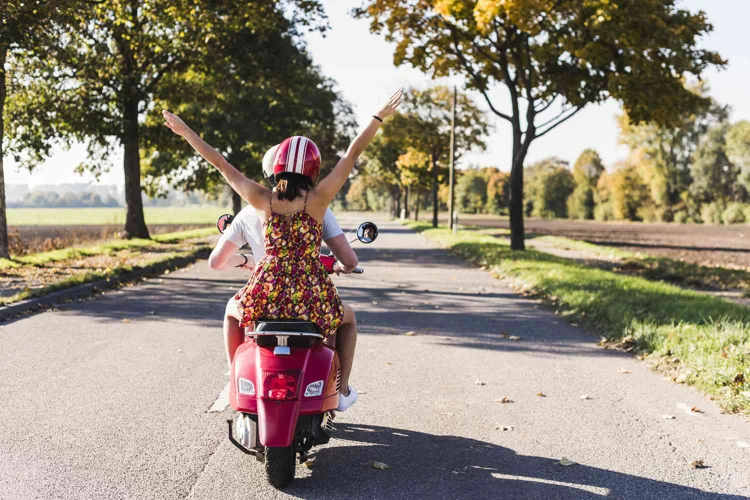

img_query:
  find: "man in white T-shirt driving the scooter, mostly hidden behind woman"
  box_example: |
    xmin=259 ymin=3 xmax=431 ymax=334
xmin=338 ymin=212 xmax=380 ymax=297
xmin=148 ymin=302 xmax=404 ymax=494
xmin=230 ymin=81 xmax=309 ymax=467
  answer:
xmin=208 ymin=145 xmax=359 ymax=411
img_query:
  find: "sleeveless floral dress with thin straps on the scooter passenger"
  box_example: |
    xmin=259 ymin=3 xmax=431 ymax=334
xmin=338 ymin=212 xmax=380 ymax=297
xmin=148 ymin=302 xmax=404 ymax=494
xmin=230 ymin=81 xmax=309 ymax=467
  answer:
xmin=234 ymin=195 xmax=344 ymax=335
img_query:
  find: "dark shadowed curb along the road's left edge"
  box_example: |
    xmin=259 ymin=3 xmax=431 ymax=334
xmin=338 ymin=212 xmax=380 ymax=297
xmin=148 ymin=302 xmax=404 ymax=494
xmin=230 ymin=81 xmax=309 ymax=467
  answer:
xmin=0 ymin=248 xmax=209 ymax=323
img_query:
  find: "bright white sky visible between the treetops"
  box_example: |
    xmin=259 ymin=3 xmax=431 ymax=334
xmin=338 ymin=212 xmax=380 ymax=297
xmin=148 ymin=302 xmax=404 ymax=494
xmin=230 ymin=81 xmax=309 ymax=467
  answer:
xmin=5 ymin=0 xmax=750 ymax=185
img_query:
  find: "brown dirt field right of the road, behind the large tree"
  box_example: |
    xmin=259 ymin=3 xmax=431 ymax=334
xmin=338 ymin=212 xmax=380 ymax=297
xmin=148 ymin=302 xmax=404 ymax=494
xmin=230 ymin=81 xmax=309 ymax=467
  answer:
xmin=461 ymin=215 xmax=750 ymax=270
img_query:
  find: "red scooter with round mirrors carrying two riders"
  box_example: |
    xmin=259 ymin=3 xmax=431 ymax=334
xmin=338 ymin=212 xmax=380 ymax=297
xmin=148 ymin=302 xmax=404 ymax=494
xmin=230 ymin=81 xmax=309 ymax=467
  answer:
xmin=217 ymin=215 xmax=378 ymax=488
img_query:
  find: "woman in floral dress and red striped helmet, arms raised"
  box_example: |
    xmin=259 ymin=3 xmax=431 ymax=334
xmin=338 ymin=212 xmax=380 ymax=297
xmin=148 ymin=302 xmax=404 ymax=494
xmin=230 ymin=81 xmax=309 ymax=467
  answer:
xmin=163 ymin=90 xmax=403 ymax=411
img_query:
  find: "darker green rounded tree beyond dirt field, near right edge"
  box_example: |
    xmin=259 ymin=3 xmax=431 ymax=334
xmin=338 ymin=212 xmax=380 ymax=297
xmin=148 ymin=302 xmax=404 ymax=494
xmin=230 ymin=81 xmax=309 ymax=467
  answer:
xmin=690 ymin=123 xmax=746 ymax=210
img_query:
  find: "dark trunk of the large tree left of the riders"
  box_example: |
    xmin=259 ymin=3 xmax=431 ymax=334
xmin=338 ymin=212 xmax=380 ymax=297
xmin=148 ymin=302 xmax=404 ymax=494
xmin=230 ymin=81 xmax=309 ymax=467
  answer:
xmin=122 ymin=97 xmax=150 ymax=238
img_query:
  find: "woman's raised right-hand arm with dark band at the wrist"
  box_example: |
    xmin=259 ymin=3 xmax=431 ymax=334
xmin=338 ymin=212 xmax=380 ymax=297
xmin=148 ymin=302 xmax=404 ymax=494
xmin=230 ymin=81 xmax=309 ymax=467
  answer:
xmin=315 ymin=89 xmax=404 ymax=207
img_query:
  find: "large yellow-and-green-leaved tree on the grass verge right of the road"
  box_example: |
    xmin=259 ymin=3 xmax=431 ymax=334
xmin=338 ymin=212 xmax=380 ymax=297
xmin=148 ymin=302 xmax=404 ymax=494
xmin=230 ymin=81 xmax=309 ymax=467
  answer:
xmin=355 ymin=0 xmax=724 ymax=250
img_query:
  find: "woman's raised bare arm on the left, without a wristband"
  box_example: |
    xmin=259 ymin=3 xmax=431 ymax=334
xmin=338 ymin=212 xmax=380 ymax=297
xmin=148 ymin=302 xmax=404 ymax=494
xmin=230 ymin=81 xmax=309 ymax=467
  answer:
xmin=162 ymin=110 xmax=269 ymax=211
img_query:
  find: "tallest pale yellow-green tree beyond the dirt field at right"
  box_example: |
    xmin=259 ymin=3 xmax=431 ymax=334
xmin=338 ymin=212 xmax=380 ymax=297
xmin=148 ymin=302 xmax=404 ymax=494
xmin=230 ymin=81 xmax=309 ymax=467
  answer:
xmin=618 ymin=83 xmax=728 ymax=211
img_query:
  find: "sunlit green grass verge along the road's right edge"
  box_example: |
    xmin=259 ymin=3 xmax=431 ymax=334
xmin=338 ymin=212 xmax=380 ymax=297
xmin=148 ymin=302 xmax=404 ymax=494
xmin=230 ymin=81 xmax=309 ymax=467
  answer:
xmin=409 ymin=223 xmax=750 ymax=414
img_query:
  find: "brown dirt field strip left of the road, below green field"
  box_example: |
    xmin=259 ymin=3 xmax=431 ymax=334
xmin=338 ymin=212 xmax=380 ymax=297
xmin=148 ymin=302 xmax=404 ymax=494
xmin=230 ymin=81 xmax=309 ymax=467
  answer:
xmin=8 ymin=222 xmax=206 ymax=256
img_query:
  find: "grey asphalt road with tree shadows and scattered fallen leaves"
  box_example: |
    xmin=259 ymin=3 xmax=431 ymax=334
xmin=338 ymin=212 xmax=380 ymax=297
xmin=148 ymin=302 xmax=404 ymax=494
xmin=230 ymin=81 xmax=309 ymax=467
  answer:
xmin=0 ymin=216 xmax=750 ymax=500
